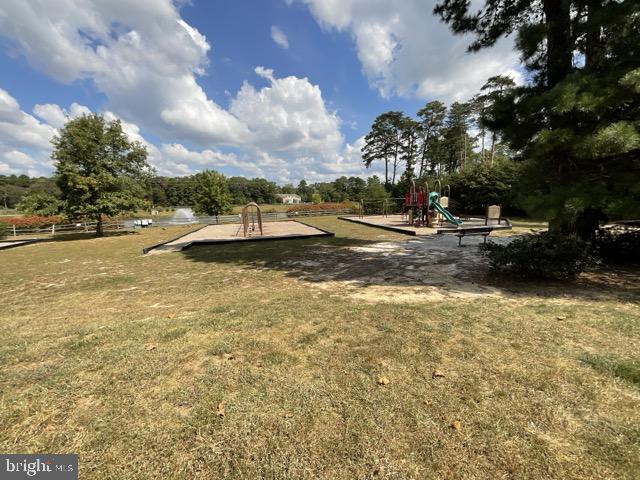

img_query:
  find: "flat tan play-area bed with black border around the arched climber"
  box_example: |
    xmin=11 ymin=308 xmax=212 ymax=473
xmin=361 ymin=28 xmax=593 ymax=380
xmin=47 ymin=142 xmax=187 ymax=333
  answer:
xmin=143 ymin=220 xmax=333 ymax=254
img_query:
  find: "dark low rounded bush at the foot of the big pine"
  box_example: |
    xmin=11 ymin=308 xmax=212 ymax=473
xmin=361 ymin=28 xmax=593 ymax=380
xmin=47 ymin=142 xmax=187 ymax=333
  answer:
xmin=480 ymin=232 xmax=596 ymax=280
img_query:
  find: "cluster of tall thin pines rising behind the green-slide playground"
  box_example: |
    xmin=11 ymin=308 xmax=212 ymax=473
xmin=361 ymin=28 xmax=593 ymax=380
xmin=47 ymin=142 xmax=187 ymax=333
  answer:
xmin=362 ymin=76 xmax=515 ymax=190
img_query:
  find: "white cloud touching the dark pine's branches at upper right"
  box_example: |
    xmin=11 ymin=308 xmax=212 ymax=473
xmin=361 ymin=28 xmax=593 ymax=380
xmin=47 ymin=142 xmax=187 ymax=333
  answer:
xmin=300 ymin=0 xmax=521 ymax=101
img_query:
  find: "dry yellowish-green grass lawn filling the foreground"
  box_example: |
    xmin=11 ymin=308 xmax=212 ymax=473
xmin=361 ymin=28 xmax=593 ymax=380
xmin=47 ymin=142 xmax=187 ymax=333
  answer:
xmin=0 ymin=217 xmax=640 ymax=479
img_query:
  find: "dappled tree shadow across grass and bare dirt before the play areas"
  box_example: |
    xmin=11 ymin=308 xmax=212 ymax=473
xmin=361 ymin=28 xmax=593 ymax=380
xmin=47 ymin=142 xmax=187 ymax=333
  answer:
xmin=182 ymin=227 xmax=640 ymax=301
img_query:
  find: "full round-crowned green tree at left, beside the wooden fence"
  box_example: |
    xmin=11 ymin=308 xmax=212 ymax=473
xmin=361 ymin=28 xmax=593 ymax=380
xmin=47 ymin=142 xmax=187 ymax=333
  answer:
xmin=51 ymin=114 xmax=151 ymax=236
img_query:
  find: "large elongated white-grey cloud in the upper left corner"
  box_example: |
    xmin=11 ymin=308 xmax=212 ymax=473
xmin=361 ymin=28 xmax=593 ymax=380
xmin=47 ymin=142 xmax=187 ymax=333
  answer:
xmin=0 ymin=0 xmax=247 ymax=145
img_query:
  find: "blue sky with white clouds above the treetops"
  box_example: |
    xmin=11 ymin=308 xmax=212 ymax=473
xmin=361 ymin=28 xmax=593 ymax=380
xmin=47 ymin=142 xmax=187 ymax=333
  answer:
xmin=0 ymin=0 xmax=520 ymax=184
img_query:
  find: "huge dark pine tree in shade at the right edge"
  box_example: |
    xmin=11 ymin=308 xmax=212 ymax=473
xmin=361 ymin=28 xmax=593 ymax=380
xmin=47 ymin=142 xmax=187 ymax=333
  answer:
xmin=435 ymin=0 xmax=640 ymax=238
